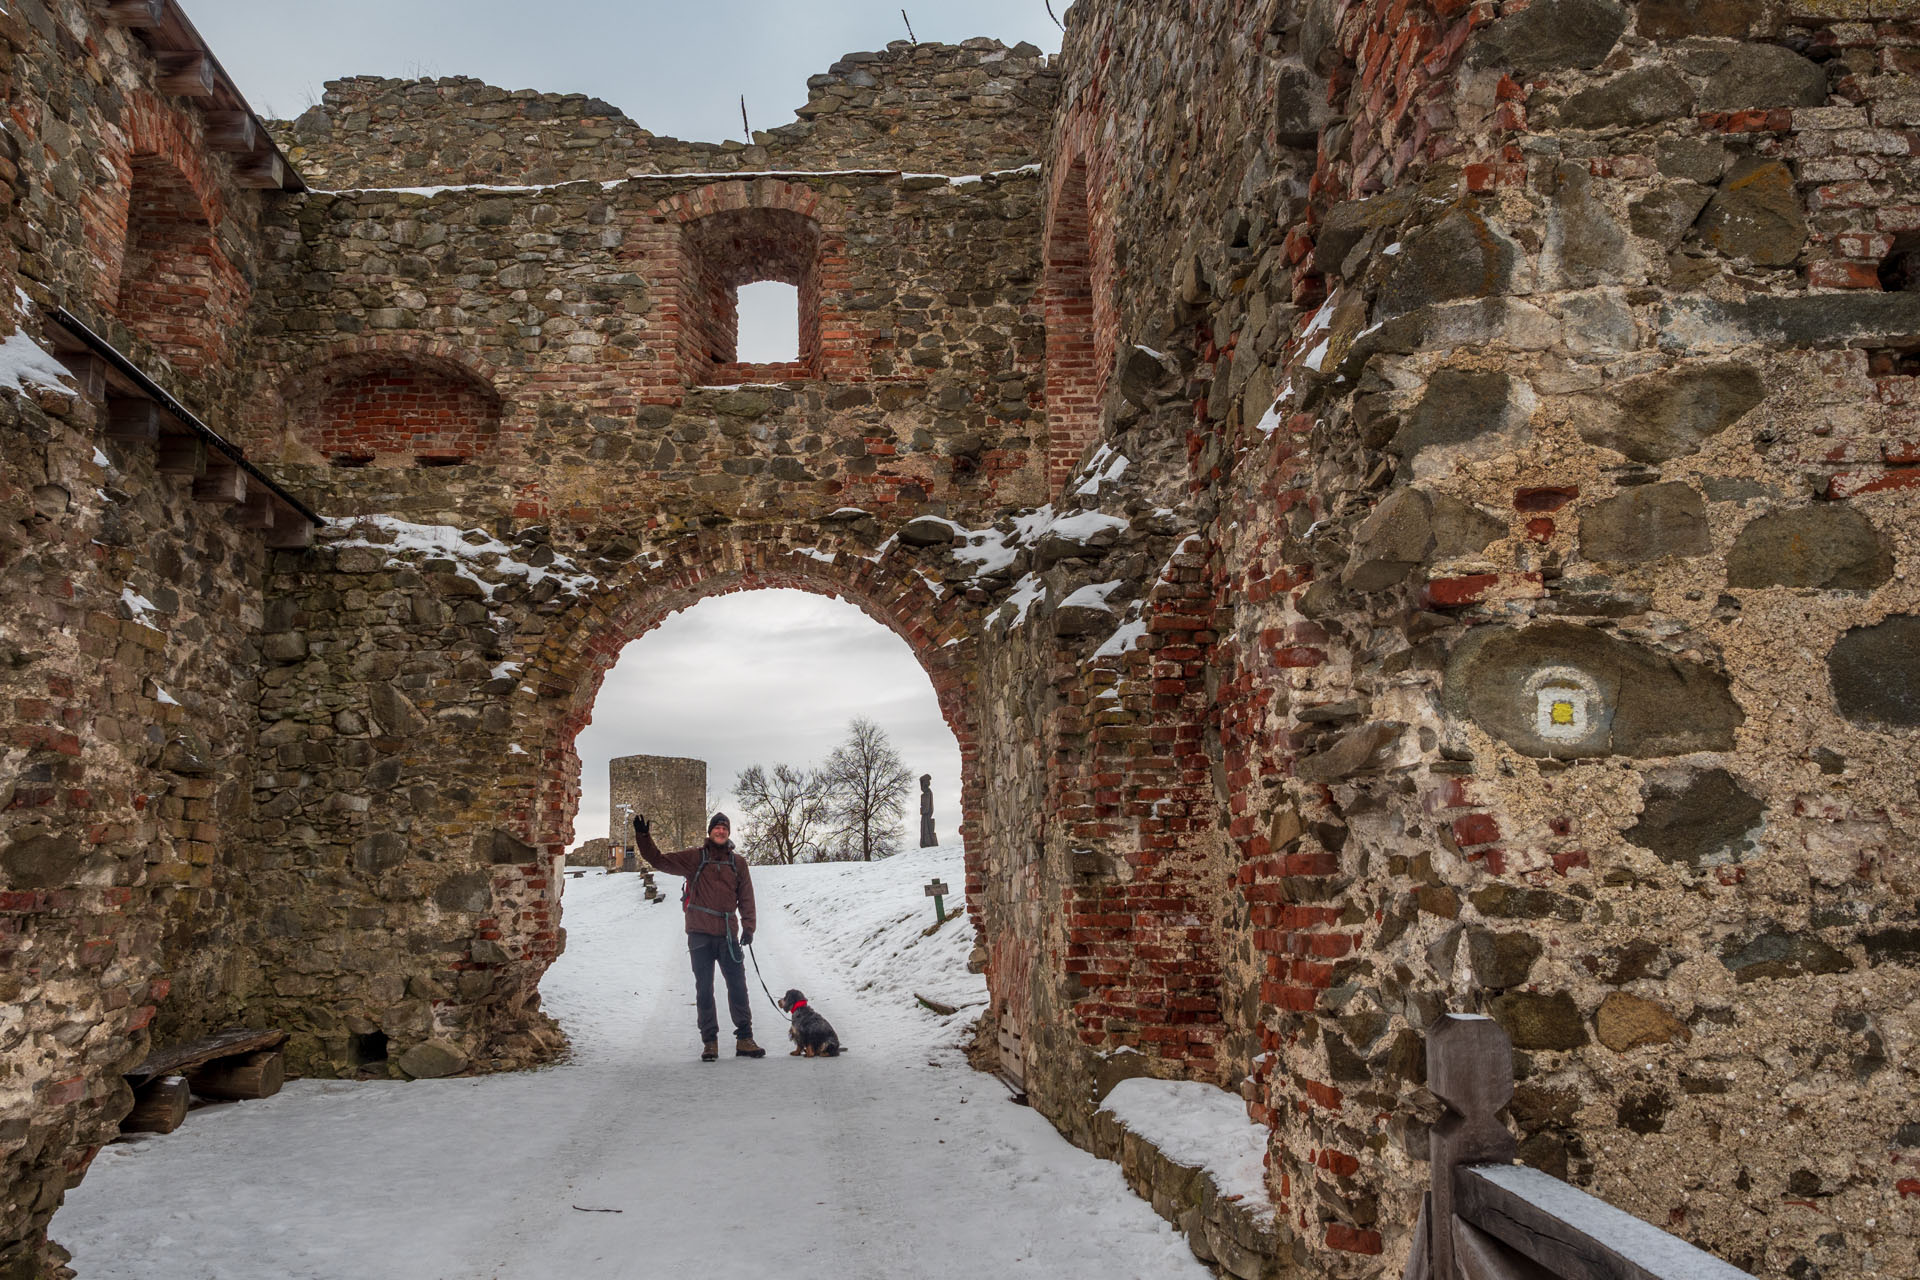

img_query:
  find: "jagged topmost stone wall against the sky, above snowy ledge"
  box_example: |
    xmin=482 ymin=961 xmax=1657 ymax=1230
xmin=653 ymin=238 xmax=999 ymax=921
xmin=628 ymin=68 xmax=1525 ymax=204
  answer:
xmin=275 ymin=38 xmax=1054 ymax=190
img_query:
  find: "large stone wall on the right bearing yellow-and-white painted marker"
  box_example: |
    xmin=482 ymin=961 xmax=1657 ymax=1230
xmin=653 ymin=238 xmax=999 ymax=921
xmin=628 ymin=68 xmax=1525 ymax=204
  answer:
xmin=1036 ymin=0 xmax=1920 ymax=1276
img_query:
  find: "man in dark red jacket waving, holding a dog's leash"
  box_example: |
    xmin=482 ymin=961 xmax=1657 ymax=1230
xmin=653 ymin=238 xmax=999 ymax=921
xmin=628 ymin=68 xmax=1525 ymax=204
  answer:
xmin=634 ymin=814 xmax=766 ymax=1063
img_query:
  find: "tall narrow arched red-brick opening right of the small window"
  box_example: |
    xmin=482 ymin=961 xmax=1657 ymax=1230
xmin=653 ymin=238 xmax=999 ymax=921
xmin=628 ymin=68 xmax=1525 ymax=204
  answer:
xmin=1043 ymin=161 xmax=1106 ymax=495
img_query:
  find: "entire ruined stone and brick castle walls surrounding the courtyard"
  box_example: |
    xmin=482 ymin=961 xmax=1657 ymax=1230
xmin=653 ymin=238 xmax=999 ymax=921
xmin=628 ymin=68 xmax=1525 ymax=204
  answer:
xmin=0 ymin=0 xmax=1920 ymax=1280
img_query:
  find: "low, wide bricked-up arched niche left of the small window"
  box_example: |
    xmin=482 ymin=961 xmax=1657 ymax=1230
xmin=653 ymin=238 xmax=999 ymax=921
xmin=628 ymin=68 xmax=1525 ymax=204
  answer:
xmin=305 ymin=353 xmax=501 ymax=466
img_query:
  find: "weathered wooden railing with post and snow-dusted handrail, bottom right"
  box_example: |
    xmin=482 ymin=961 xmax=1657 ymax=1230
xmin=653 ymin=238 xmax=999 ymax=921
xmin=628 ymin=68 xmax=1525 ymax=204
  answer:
xmin=1404 ymin=1013 xmax=1751 ymax=1280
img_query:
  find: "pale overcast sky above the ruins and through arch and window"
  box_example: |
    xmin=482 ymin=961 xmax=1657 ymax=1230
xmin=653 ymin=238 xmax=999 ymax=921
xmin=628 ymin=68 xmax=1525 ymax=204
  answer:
xmin=180 ymin=0 xmax=1066 ymax=859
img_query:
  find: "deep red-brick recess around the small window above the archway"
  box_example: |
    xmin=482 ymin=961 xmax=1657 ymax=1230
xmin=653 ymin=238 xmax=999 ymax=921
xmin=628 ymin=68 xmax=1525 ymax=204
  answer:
xmin=680 ymin=209 xmax=820 ymax=386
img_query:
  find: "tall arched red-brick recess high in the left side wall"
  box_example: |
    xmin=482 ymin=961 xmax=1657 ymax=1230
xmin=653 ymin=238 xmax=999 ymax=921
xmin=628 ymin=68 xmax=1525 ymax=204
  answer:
xmin=113 ymin=155 xmax=238 ymax=372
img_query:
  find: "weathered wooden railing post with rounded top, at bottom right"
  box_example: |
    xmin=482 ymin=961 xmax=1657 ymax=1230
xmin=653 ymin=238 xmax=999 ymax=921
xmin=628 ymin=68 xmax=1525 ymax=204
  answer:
xmin=1415 ymin=1013 xmax=1515 ymax=1280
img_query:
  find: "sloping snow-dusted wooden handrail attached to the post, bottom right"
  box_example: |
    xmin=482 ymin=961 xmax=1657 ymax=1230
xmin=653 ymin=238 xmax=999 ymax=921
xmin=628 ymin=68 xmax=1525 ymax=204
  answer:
xmin=1453 ymin=1165 xmax=1753 ymax=1280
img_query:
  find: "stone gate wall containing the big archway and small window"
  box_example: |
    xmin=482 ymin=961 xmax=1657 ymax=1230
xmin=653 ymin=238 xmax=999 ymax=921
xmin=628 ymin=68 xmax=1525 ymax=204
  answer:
xmin=226 ymin=55 xmax=1067 ymax=1073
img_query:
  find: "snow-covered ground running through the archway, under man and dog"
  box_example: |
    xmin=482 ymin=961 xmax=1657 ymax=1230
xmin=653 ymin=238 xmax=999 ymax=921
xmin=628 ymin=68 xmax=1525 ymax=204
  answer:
xmin=54 ymin=846 xmax=1208 ymax=1280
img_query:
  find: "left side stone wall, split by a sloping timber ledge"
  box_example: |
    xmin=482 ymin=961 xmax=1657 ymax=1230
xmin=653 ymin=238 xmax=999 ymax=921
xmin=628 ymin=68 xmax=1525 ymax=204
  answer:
xmin=0 ymin=0 xmax=295 ymax=1276
